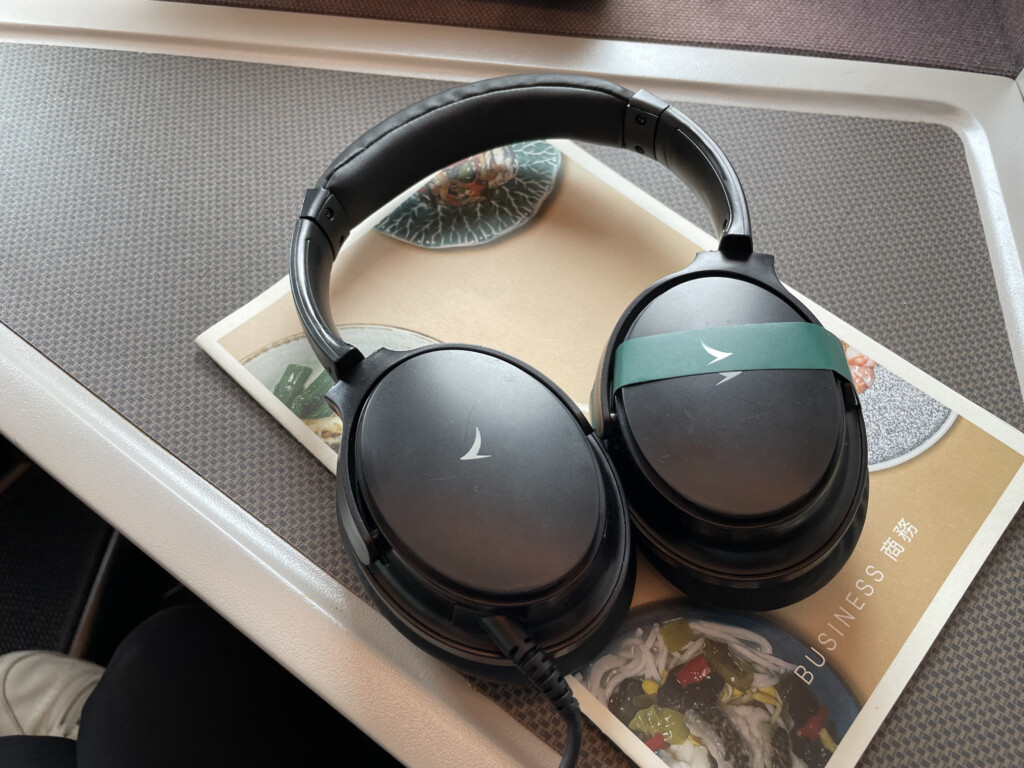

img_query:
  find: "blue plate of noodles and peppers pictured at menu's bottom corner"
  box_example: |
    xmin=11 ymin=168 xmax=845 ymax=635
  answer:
xmin=581 ymin=601 xmax=859 ymax=768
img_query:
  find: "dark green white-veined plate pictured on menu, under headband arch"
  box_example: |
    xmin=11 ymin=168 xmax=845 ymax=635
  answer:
xmin=377 ymin=141 xmax=562 ymax=248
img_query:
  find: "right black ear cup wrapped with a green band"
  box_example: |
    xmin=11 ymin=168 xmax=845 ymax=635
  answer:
xmin=591 ymin=253 xmax=867 ymax=610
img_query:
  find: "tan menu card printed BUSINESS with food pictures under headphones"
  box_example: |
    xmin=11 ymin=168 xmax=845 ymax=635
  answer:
xmin=198 ymin=141 xmax=1024 ymax=768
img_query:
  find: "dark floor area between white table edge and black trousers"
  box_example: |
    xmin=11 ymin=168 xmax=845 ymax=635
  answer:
xmin=0 ymin=436 xmax=207 ymax=665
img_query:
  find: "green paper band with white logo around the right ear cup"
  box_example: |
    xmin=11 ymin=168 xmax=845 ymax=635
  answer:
xmin=612 ymin=323 xmax=852 ymax=392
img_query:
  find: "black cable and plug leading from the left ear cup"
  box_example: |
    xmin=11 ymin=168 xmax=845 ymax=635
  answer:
xmin=480 ymin=616 xmax=583 ymax=768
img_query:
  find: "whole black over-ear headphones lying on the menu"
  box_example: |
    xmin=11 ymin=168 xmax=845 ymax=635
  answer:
xmin=291 ymin=75 xmax=867 ymax=765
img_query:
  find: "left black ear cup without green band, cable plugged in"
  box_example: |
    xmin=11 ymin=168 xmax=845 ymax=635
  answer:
xmin=332 ymin=345 xmax=635 ymax=681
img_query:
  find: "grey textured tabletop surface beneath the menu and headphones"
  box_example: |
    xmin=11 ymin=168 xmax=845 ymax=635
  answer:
xmin=0 ymin=44 xmax=1024 ymax=766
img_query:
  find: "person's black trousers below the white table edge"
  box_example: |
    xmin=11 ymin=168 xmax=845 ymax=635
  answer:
xmin=0 ymin=605 xmax=399 ymax=768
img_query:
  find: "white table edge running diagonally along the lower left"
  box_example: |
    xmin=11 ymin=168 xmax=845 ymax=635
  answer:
xmin=0 ymin=324 xmax=555 ymax=768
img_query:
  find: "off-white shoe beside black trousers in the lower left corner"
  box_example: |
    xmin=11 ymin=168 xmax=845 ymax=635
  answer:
xmin=0 ymin=650 xmax=103 ymax=738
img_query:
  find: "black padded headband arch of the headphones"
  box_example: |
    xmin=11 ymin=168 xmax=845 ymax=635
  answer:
xmin=291 ymin=75 xmax=753 ymax=381
